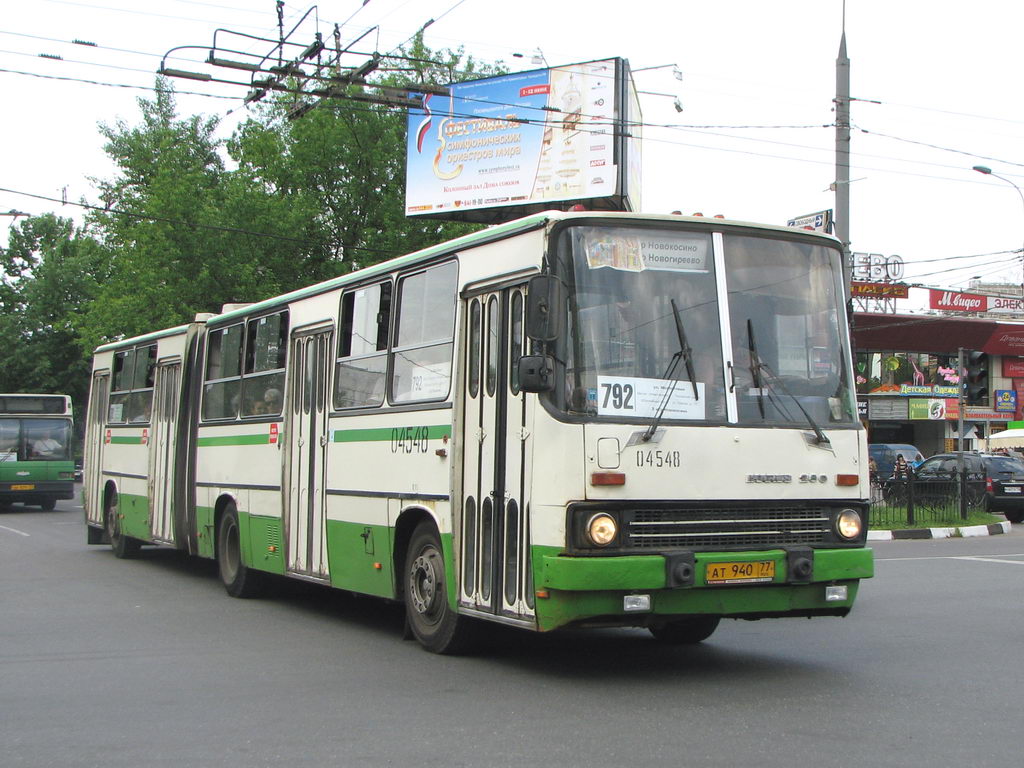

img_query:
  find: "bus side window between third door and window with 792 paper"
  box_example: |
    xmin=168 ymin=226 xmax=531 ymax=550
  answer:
xmin=334 ymin=283 xmax=391 ymax=409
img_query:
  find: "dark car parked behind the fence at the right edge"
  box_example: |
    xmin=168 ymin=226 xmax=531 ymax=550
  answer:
xmin=914 ymin=452 xmax=1024 ymax=522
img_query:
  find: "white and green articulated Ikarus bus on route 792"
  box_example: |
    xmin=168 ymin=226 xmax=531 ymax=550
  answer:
xmin=85 ymin=212 xmax=873 ymax=652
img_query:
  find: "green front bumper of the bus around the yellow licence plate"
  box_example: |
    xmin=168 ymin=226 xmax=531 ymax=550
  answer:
xmin=536 ymin=549 xmax=874 ymax=631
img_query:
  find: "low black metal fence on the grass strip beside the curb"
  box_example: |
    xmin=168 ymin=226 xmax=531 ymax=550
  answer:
xmin=868 ymin=472 xmax=985 ymax=528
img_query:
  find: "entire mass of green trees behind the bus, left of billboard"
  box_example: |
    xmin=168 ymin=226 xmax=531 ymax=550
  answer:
xmin=0 ymin=37 xmax=505 ymax=402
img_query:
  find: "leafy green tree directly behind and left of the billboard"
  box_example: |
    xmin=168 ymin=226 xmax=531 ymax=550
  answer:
xmin=227 ymin=35 xmax=507 ymax=280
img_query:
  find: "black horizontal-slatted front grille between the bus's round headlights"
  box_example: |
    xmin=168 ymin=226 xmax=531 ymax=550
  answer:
xmin=625 ymin=507 xmax=833 ymax=549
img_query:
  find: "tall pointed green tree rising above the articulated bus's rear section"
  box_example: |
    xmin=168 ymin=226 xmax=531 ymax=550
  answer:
xmin=85 ymin=78 xmax=245 ymax=348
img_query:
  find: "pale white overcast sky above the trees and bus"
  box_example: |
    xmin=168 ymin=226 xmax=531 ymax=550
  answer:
xmin=0 ymin=0 xmax=1024 ymax=304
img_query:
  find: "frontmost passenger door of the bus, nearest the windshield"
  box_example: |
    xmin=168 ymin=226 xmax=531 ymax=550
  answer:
xmin=459 ymin=286 xmax=534 ymax=620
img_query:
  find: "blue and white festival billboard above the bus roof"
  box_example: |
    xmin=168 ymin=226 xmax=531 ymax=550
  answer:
xmin=406 ymin=58 xmax=641 ymax=222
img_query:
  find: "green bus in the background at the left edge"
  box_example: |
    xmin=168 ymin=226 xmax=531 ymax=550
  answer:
xmin=0 ymin=394 xmax=75 ymax=510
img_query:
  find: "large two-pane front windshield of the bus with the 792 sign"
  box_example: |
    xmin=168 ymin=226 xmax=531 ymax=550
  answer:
xmin=554 ymin=226 xmax=856 ymax=428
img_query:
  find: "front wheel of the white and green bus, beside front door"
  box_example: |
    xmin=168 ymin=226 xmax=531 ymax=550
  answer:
xmin=402 ymin=521 xmax=476 ymax=654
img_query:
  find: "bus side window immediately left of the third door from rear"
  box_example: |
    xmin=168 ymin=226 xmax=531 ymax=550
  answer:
xmin=242 ymin=312 xmax=288 ymax=416
